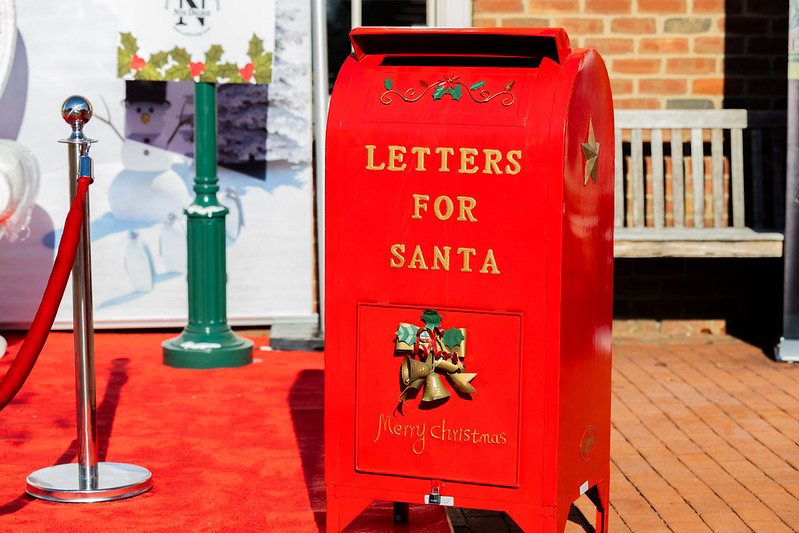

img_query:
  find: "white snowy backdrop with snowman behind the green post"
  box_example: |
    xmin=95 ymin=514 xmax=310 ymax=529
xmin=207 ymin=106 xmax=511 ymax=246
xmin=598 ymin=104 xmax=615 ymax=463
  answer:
xmin=0 ymin=0 xmax=316 ymax=328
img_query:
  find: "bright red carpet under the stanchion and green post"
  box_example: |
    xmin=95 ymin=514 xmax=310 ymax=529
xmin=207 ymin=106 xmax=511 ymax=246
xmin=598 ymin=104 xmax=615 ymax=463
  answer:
xmin=0 ymin=333 xmax=449 ymax=533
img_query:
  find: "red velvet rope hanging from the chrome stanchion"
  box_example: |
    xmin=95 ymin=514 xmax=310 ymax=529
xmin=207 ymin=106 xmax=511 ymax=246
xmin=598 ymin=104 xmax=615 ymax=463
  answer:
xmin=0 ymin=176 xmax=91 ymax=410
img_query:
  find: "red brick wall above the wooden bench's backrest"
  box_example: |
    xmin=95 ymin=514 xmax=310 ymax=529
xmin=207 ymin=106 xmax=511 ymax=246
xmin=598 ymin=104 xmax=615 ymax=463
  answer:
xmin=473 ymin=0 xmax=789 ymax=109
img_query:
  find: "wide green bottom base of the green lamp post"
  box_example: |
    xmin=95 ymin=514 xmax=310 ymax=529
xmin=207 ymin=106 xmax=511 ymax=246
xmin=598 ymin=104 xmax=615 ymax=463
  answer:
xmin=161 ymin=328 xmax=252 ymax=368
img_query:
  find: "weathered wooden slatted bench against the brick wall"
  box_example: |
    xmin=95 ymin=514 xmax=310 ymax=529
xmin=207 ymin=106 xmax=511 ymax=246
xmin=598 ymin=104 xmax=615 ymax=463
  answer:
xmin=615 ymin=109 xmax=785 ymax=257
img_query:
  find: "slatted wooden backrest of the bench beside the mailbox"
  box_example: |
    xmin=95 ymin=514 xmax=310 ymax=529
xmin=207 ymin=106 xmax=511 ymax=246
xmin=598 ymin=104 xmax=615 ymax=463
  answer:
xmin=615 ymin=109 xmax=785 ymax=228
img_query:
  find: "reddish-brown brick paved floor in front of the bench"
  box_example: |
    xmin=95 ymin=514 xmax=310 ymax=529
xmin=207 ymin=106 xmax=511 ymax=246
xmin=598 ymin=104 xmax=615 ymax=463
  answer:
xmin=450 ymin=335 xmax=799 ymax=533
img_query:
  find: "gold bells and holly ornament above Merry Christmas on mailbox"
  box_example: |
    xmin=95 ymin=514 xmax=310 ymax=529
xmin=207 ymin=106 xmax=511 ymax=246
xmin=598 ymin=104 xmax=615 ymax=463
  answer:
xmin=394 ymin=309 xmax=477 ymax=407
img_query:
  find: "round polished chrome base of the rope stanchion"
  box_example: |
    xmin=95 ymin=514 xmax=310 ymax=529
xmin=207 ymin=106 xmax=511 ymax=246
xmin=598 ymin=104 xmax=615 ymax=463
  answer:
xmin=26 ymin=463 xmax=153 ymax=503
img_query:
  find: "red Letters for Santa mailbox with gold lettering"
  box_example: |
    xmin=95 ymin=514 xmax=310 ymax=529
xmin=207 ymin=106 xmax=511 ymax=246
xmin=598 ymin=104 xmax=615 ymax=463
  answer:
xmin=325 ymin=28 xmax=614 ymax=531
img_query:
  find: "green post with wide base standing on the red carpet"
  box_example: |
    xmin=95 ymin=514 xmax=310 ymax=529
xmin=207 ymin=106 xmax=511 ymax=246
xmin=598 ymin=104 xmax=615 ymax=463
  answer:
xmin=162 ymin=83 xmax=252 ymax=368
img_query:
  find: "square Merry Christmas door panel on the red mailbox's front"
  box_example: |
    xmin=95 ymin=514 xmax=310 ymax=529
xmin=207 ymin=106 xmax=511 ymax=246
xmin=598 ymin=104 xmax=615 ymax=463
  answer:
xmin=355 ymin=304 xmax=524 ymax=487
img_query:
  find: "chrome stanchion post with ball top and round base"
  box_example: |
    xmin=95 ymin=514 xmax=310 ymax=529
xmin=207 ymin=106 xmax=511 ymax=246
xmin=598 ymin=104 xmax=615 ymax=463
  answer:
xmin=27 ymin=96 xmax=152 ymax=503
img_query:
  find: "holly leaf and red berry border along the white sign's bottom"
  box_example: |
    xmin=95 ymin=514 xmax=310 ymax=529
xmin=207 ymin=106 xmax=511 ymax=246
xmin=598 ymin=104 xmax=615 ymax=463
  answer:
xmin=117 ymin=32 xmax=272 ymax=84
